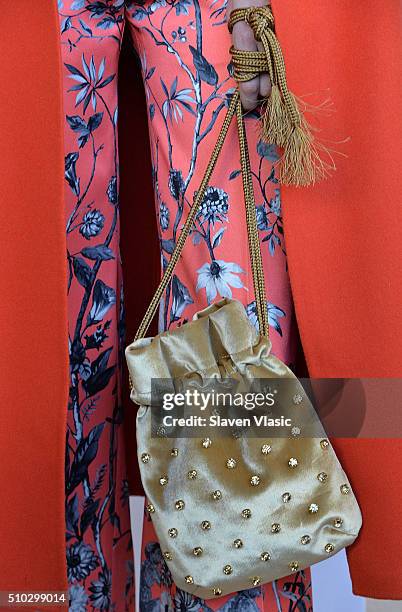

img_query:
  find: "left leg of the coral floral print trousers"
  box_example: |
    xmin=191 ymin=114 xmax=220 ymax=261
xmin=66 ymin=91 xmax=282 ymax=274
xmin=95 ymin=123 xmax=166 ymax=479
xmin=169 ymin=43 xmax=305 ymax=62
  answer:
xmin=59 ymin=0 xmax=134 ymax=612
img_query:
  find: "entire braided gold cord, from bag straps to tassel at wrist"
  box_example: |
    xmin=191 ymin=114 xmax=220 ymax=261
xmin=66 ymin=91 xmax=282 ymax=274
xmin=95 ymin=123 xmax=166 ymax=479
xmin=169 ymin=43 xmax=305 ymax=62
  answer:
xmin=129 ymin=2 xmax=332 ymax=389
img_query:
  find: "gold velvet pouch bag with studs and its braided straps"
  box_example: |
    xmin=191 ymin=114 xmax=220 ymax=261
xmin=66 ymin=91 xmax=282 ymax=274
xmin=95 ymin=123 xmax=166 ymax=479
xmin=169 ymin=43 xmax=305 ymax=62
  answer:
xmin=125 ymin=91 xmax=361 ymax=599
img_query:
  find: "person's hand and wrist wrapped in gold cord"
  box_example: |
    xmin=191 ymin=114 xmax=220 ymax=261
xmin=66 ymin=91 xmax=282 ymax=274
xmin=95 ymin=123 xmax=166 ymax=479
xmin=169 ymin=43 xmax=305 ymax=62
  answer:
xmin=226 ymin=0 xmax=271 ymax=110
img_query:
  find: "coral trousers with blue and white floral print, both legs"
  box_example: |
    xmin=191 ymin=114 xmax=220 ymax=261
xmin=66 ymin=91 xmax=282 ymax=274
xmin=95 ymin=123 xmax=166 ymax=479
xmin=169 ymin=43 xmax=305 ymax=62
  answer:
xmin=58 ymin=0 xmax=312 ymax=612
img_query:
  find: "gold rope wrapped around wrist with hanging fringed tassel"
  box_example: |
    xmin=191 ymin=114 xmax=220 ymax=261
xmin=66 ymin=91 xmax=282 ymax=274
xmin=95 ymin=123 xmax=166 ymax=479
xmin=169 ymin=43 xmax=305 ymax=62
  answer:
xmin=228 ymin=6 xmax=335 ymax=186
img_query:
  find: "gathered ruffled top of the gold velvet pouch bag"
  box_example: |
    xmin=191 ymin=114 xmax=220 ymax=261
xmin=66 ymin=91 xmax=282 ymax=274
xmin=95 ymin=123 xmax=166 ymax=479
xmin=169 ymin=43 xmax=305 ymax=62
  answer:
xmin=126 ymin=298 xmax=288 ymax=405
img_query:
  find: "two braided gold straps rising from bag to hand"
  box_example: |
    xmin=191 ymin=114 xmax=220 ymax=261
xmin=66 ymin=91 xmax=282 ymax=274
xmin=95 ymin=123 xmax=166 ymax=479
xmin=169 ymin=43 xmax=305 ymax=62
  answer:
xmin=134 ymin=90 xmax=269 ymax=350
